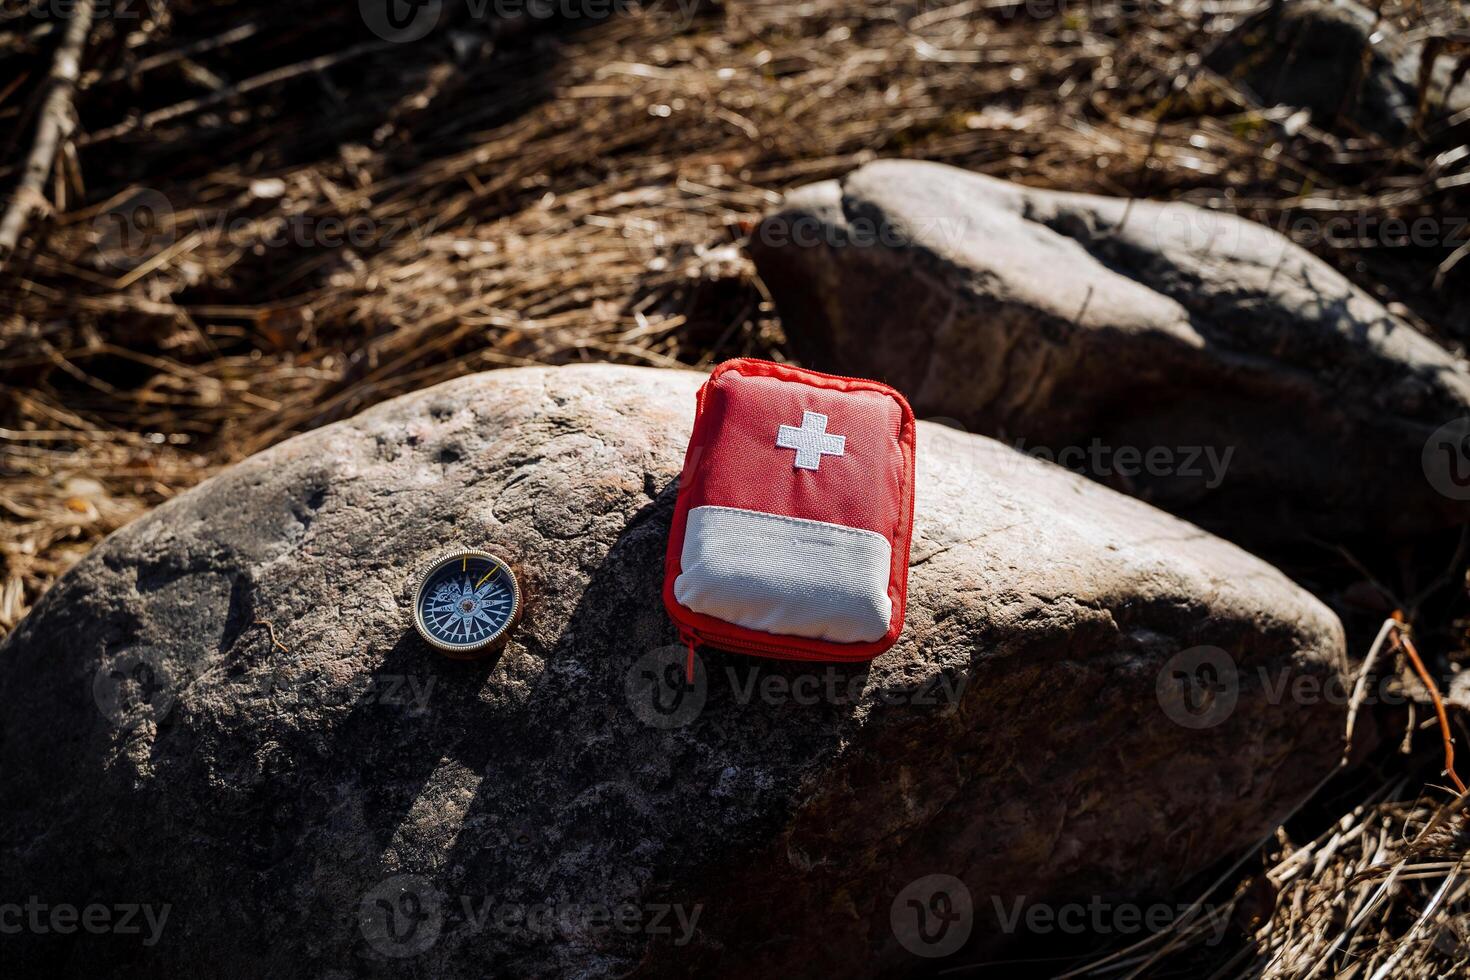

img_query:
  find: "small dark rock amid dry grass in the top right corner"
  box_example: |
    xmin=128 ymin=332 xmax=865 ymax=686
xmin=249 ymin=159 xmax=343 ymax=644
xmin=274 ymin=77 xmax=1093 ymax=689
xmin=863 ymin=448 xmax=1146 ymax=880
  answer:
xmin=1210 ymin=0 xmax=1470 ymax=143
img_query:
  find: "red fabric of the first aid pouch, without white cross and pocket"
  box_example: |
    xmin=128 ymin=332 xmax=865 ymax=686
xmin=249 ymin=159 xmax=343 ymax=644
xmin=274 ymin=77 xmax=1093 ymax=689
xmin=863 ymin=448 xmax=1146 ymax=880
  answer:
xmin=663 ymin=359 xmax=914 ymax=661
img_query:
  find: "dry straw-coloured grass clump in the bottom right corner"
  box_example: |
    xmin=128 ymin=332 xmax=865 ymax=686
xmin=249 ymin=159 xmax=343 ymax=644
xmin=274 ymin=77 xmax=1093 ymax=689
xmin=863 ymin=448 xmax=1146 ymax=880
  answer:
xmin=1066 ymin=777 xmax=1470 ymax=980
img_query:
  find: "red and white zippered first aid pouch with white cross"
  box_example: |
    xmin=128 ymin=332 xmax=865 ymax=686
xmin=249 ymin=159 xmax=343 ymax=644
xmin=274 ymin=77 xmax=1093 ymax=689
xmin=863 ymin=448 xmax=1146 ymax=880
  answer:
xmin=663 ymin=359 xmax=914 ymax=670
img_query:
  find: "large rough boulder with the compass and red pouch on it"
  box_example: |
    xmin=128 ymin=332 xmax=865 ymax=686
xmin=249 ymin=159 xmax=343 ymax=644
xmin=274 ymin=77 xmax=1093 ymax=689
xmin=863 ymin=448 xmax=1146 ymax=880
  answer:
xmin=0 ymin=367 xmax=1342 ymax=979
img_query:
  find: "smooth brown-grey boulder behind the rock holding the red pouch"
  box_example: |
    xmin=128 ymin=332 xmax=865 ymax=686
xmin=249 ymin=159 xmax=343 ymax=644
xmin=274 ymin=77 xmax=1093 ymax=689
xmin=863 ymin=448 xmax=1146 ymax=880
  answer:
xmin=751 ymin=160 xmax=1470 ymax=544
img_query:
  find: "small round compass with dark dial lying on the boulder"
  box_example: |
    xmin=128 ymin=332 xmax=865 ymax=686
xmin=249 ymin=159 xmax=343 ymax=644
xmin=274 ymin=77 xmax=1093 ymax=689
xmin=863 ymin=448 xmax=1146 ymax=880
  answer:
xmin=413 ymin=551 xmax=520 ymax=658
